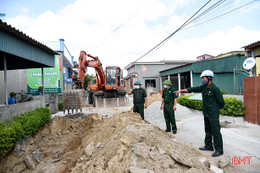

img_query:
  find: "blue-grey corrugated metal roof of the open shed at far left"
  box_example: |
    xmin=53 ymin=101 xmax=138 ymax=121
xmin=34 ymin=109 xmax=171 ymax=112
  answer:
xmin=0 ymin=20 xmax=58 ymax=70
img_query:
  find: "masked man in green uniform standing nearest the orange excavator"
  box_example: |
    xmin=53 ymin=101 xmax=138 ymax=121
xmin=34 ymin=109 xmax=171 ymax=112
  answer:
xmin=132 ymin=81 xmax=147 ymax=120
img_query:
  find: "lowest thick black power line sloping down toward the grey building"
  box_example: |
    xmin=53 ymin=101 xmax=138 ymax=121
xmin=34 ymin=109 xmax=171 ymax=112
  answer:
xmin=133 ymin=0 xmax=211 ymax=63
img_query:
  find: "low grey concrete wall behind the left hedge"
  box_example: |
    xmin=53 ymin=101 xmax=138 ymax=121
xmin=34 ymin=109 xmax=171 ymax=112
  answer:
xmin=0 ymin=95 xmax=45 ymax=122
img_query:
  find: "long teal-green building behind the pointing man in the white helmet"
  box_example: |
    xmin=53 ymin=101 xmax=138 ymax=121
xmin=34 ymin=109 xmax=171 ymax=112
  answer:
xmin=160 ymin=51 xmax=249 ymax=94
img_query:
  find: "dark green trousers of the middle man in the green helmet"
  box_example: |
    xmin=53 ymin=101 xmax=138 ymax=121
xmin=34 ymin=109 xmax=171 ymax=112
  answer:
xmin=163 ymin=104 xmax=177 ymax=132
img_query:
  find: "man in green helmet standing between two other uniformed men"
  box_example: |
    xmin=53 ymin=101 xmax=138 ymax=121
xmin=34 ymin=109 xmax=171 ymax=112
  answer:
xmin=161 ymin=80 xmax=177 ymax=134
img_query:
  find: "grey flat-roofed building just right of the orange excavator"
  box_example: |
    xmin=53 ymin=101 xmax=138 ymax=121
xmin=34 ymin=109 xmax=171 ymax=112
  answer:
xmin=124 ymin=60 xmax=194 ymax=94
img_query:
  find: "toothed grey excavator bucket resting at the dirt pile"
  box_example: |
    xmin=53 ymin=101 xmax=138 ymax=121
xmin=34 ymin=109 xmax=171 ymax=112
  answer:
xmin=63 ymin=89 xmax=87 ymax=114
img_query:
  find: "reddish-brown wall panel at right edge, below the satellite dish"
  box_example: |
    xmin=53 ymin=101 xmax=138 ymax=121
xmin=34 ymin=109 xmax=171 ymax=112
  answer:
xmin=243 ymin=76 xmax=260 ymax=125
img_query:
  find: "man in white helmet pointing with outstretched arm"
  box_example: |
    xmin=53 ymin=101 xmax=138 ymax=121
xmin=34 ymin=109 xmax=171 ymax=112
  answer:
xmin=176 ymin=70 xmax=225 ymax=157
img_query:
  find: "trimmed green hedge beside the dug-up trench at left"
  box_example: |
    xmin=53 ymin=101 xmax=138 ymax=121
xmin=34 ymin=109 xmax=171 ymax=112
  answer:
xmin=0 ymin=108 xmax=51 ymax=158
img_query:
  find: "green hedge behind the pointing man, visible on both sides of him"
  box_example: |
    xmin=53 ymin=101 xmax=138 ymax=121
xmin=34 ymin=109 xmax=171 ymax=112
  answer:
xmin=177 ymin=95 xmax=245 ymax=117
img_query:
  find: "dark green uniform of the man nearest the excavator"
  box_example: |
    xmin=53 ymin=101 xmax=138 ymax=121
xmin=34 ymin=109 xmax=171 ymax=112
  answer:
xmin=132 ymin=87 xmax=147 ymax=120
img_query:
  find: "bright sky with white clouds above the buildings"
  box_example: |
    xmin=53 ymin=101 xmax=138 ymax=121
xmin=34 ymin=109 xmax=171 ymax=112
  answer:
xmin=0 ymin=0 xmax=260 ymax=73
